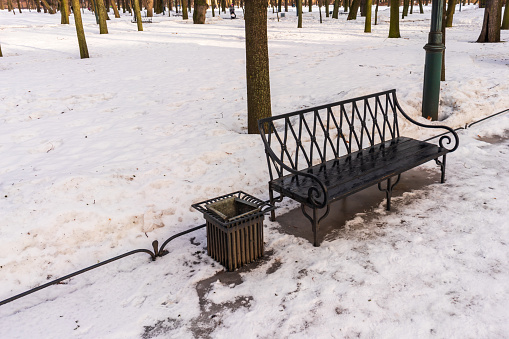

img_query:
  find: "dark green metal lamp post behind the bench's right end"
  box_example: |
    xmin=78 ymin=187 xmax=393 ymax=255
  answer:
xmin=422 ymin=0 xmax=445 ymax=120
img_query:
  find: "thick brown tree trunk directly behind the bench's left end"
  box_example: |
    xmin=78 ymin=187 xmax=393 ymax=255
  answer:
xmin=245 ymin=0 xmax=272 ymax=134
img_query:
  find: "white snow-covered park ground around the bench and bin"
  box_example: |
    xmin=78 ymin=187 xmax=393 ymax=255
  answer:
xmin=0 ymin=6 xmax=509 ymax=338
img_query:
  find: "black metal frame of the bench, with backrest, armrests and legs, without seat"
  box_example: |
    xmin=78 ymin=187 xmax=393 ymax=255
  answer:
xmin=258 ymin=89 xmax=459 ymax=246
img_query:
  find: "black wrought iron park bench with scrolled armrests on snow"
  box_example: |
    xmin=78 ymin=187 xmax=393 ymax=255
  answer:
xmin=258 ymin=89 xmax=459 ymax=246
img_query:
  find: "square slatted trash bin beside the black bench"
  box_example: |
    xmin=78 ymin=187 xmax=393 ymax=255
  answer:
xmin=192 ymin=191 xmax=274 ymax=271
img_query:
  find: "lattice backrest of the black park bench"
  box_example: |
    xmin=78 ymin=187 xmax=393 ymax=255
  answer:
xmin=258 ymin=89 xmax=400 ymax=180
